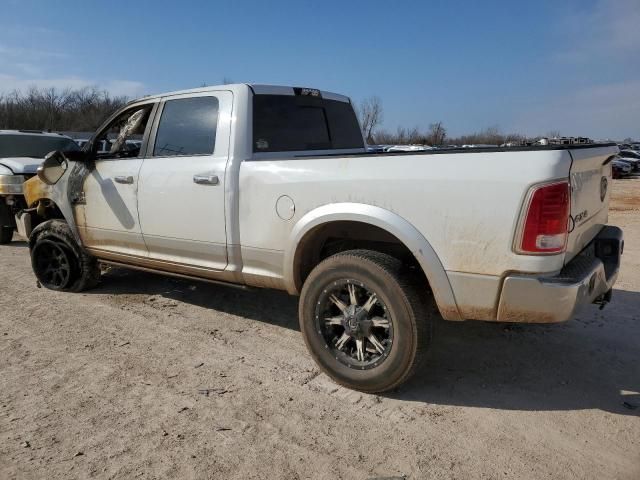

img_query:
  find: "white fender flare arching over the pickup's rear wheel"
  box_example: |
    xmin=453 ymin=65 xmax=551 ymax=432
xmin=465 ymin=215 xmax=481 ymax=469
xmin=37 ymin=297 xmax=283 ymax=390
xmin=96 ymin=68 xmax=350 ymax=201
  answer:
xmin=283 ymin=203 xmax=462 ymax=320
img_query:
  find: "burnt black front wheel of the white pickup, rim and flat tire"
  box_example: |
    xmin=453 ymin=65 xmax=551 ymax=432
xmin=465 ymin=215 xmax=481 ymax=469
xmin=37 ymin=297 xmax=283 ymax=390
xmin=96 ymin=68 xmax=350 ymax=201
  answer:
xmin=29 ymin=220 xmax=100 ymax=292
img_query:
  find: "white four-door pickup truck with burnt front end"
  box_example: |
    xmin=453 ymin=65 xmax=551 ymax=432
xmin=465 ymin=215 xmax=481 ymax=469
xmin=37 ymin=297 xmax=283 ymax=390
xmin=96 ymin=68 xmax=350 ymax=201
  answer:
xmin=18 ymin=84 xmax=623 ymax=392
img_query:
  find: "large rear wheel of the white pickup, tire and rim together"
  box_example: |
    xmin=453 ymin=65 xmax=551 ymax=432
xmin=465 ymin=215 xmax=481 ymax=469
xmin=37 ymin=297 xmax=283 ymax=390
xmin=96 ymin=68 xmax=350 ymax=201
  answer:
xmin=299 ymin=250 xmax=432 ymax=393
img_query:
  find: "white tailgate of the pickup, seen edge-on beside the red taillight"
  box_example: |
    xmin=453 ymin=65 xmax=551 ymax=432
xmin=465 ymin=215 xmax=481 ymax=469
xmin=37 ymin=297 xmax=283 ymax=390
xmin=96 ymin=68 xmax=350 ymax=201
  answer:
xmin=565 ymin=146 xmax=618 ymax=263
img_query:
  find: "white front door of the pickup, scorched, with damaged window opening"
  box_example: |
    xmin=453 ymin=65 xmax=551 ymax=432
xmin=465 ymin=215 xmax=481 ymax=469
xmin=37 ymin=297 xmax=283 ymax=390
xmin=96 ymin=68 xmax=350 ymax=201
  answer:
xmin=75 ymin=103 xmax=154 ymax=257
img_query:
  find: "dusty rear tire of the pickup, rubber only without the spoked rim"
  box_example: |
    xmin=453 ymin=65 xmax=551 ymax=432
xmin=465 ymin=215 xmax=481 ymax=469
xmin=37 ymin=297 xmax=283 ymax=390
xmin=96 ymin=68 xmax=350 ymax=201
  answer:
xmin=299 ymin=250 xmax=437 ymax=393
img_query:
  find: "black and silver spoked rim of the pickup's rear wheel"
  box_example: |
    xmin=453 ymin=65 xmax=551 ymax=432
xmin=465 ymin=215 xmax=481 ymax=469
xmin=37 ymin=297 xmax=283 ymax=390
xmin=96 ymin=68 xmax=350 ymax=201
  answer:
xmin=315 ymin=279 xmax=393 ymax=370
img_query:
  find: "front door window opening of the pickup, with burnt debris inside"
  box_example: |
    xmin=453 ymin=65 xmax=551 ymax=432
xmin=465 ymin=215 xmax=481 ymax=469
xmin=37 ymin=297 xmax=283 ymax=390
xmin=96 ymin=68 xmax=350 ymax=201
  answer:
xmin=93 ymin=105 xmax=153 ymax=158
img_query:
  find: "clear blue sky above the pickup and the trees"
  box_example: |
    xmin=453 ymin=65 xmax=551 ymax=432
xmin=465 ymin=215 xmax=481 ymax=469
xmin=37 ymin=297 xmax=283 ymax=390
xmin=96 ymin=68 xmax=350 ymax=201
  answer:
xmin=0 ymin=0 xmax=640 ymax=138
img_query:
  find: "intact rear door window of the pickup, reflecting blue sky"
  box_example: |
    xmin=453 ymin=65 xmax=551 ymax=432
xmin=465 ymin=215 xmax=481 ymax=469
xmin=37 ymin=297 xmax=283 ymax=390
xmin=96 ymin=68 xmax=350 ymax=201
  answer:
xmin=153 ymin=97 xmax=218 ymax=157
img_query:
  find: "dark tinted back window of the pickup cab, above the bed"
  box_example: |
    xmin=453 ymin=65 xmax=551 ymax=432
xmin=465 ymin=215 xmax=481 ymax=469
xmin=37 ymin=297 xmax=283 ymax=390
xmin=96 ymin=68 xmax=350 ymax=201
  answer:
xmin=253 ymin=95 xmax=364 ymax=153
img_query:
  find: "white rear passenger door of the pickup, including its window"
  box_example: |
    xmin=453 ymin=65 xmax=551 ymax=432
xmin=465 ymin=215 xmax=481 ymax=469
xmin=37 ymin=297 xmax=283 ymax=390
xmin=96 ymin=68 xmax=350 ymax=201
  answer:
xmin=138 ymin=91 xmax=233 ymax=270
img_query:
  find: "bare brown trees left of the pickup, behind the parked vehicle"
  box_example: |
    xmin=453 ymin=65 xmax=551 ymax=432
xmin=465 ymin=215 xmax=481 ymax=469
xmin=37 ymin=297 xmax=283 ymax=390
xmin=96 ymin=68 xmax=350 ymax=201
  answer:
xmin=0 ymin=87 xmax=128 ymax=132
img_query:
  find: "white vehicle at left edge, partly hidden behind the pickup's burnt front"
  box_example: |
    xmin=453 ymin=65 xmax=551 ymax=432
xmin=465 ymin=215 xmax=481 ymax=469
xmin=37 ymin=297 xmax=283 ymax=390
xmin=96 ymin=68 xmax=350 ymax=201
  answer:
xmin=0 ymin=130 xmax=79 ymax=243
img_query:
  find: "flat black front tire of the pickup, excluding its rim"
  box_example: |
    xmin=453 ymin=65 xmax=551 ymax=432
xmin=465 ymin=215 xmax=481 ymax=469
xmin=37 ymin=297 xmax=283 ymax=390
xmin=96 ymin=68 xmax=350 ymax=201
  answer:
xmin=29 ymin=220 xmax=100 ymax=292
